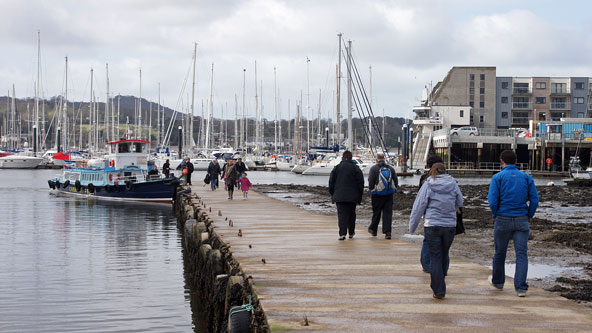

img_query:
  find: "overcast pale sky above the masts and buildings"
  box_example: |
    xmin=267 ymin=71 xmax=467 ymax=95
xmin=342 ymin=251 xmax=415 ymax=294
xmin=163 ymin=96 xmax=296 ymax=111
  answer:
xmin=0 ymin=0 xmax=592 ymax=119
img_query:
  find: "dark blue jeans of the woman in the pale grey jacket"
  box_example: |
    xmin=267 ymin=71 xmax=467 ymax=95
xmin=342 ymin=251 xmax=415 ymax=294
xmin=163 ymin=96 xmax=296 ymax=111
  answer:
xmin=423 ymin=226 xmax=456 ymax=296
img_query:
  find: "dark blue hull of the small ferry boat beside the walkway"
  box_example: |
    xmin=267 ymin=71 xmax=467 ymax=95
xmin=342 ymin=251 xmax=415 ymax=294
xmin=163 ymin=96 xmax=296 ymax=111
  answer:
xmin=50 ymin=178 xmax=176 ymax=203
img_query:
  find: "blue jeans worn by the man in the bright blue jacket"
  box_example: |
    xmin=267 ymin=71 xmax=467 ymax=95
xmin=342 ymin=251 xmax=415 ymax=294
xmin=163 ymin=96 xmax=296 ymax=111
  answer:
xmin=491 ymin=215 xmax=530 ymax=291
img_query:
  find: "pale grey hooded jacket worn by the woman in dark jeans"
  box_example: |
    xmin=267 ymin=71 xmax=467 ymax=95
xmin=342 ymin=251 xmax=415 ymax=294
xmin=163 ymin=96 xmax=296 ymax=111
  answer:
xmin=409 ymin=175 xmax=463 ymax=233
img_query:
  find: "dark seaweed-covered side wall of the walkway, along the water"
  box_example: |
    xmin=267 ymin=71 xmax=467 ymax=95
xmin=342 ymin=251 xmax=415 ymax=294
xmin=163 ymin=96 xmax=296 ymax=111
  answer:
xmin=174 ymin=189 xmax=269 ymax=332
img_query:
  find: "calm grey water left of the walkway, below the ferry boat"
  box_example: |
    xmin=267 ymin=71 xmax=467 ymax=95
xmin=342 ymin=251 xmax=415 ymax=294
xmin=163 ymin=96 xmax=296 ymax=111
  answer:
xmin=0 ymin=170 xmax=193 ymax=332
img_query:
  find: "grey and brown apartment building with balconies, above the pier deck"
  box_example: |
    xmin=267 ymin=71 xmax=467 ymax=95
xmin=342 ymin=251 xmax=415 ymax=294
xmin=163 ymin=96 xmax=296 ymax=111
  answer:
xmin=431 ymin=66 xmax=592 ymax=128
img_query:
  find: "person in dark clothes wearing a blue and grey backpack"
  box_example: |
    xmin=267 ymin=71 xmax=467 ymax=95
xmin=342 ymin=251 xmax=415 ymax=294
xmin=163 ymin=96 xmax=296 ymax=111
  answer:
xmin=368 ymin=153 xmax=399 ymax=239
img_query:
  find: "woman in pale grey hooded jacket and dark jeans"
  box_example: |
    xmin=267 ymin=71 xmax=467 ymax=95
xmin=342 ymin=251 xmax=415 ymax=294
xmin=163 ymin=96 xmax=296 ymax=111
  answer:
xmin=409 ymin=163 xmax=463 ymax=299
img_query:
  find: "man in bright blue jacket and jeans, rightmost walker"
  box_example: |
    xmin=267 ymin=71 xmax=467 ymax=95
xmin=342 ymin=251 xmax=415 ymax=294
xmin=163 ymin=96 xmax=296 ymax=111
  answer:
xmin=487 ymin=150 xmax=539 ymax=297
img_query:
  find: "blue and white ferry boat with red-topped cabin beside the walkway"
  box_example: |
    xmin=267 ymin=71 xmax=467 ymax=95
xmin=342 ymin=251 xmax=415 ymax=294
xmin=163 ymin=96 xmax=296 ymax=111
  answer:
xmin=48 ymin=139 xmax=178 ymax=203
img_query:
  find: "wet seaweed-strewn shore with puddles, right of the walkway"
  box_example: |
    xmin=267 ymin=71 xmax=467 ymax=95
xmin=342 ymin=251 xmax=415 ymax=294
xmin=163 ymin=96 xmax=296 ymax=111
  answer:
xmin=253 ymin=185 xmax=592 ymax=306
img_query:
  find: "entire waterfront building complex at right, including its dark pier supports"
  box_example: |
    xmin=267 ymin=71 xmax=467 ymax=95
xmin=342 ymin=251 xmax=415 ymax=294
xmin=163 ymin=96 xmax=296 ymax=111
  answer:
xmin=409 ymin=66 xmax=592 ymax=172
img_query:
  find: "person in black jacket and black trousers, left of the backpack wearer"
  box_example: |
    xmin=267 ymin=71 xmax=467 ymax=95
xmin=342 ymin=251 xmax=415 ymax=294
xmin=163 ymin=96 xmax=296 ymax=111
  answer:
xmin=329 ymin=150 xmax=364 ymax=240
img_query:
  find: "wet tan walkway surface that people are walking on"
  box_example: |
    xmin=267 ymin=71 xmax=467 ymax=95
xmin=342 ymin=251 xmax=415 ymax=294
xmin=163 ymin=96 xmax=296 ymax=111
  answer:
xmin=192 ymin=185 xmax=592 ymax=332
